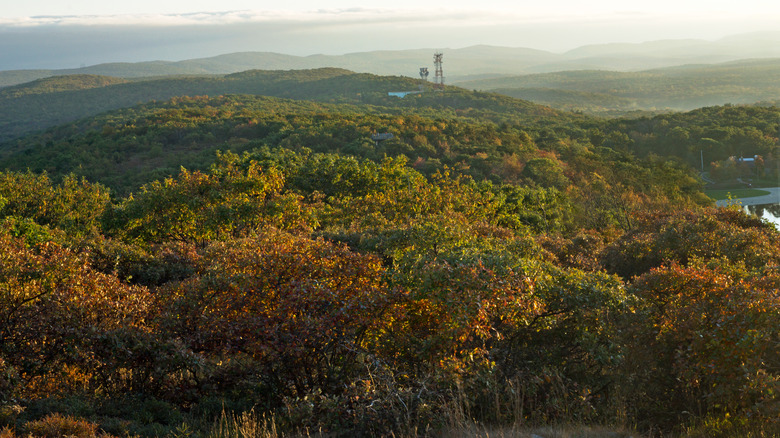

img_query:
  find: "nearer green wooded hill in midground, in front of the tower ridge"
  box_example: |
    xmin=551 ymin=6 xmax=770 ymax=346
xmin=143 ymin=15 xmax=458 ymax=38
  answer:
xmin=0 ymin=92 xmax=574 ymax=192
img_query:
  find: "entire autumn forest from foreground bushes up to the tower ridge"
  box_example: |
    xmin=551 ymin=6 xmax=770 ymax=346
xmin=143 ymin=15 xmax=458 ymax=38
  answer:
xmin=0 ymin=69 xmax=780 ymax=438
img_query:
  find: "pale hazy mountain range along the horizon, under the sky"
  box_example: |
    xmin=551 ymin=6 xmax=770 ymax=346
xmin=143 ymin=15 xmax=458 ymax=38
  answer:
xmin=0 ymin=32 xmax=780 ymax=87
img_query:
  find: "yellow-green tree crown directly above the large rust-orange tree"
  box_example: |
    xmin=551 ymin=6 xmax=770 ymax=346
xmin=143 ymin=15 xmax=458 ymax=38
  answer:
xmin=107 ymin=158 xmax=316 ymax=244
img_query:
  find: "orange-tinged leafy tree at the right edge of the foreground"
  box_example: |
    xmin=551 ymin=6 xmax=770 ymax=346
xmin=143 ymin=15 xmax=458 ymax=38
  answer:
xmin=627 ymin=261 xmax=780 ymax=415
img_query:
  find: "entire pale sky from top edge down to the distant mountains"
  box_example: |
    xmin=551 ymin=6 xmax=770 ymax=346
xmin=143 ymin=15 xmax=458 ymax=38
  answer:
xmin=0 ymin=0 xmax=780 ymax=70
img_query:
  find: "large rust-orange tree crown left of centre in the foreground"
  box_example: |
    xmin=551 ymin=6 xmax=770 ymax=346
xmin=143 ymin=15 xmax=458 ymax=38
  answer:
xmin=155 ymin=229 xmax=392 ymax=391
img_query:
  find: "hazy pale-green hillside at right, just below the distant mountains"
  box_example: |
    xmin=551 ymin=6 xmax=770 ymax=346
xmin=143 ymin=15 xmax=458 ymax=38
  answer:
xmin=458 ymin=59 xmax=780 ymax=114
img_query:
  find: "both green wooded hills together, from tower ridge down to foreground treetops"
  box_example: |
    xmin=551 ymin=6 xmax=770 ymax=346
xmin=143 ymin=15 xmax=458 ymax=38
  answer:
xmin=0 ymin=68 xmax=582 ymax=192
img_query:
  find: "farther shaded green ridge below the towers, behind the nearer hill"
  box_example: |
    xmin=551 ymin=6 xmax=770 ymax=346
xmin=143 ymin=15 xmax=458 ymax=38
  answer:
xmin=0 ymin=69 xmax=560 ymax=142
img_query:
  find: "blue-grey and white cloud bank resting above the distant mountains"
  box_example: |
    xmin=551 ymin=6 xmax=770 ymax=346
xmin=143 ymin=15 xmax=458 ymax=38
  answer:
xmin=0 ymin=8 xmax=776 ymax=70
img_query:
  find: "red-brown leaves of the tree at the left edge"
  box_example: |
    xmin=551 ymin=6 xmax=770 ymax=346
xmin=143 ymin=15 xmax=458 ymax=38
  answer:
xmin=0 ymin=226 xmax=157 ymax=396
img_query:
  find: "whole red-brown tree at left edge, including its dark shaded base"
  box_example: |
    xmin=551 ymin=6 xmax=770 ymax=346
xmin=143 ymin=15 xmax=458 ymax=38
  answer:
xmin=0 ymin=229 xmax=170 ymax=396
